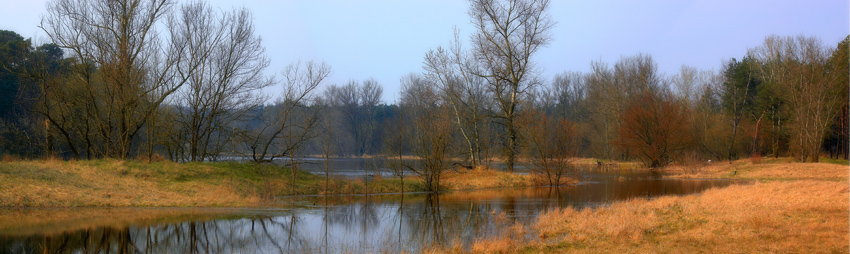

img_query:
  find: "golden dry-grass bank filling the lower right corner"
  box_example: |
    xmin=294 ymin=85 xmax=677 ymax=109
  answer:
xmin=458 ymin=160 xmax=850 ymax=253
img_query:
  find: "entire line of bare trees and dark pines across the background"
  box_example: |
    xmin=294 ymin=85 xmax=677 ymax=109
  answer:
xmin=0 ymin=0 xmax=850 ymax=170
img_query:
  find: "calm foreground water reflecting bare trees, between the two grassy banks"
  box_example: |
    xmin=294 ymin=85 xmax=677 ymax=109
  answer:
xmin=0 ymin=168 xmax=740 ymax=253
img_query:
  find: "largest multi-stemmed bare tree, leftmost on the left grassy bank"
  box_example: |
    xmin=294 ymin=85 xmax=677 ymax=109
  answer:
xmin=40 ymin=0 xmax=205 ymax=158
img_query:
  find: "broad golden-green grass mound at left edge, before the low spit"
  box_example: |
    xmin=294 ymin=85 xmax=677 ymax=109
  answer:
xmin=0 ymin=160 xmax=284 ymax=207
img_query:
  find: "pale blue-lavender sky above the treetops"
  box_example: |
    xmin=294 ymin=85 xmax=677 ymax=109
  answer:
xmin=0 ymin=0 xmax=850 ymax=103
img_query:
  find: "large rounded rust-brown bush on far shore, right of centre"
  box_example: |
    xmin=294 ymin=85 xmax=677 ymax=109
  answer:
xmin=615 ymin=90 xmax=692 ymax=168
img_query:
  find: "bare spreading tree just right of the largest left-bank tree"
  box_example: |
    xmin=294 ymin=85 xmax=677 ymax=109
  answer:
xmin=175 ymin=2 xmax=274 ymax=161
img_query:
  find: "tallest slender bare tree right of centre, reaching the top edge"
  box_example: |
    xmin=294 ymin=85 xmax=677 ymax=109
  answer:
xmin=469 ymin=0 xmax=555 ymax=172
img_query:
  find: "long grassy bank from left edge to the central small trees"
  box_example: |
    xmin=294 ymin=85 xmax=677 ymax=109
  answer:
xmin=0 ymin=159 xmax=544 ymax=207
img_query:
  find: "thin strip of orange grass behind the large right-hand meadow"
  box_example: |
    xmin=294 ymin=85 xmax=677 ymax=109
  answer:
xmin=661 ymin=159 xmax=850 ymax=180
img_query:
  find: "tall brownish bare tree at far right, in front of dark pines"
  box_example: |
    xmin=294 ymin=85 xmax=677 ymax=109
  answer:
xmin=748 ymin=35 xmax=847 ymax=162
